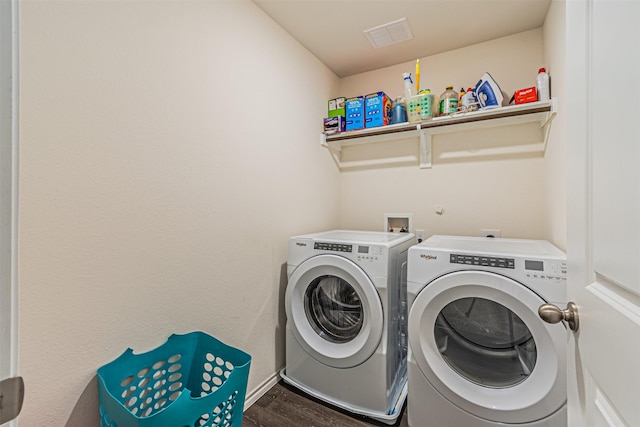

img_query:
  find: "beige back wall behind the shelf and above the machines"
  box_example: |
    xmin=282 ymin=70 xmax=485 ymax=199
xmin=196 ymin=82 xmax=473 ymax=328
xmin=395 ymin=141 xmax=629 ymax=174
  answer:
xmin=340 ymin=29 xmax=549 ymax=239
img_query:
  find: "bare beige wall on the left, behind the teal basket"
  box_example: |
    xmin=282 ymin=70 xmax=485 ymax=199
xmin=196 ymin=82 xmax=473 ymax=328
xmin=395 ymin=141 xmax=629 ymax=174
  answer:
xmin=19 ymin=0 xmax=339 ymax=427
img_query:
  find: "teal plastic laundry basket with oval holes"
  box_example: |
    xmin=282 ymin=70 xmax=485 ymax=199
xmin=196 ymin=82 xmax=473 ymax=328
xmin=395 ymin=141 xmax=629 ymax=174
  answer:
xmin=98 ymin=332 xmax=251 ymax=427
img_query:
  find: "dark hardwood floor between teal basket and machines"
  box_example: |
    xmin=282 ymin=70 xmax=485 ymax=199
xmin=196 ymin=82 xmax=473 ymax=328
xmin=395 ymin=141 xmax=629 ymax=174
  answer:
xmin=242 ymin=381 xmax=409 ymax=427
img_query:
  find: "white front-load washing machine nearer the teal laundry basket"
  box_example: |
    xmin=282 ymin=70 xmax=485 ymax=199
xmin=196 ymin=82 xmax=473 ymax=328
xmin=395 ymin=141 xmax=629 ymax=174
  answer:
xmin=280 ymin=230 xmax=415 ymax=424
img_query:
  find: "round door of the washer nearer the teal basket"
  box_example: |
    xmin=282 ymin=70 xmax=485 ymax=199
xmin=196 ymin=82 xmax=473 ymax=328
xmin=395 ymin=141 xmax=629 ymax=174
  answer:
xmin=285 ymin=255 xmax=384 ymax=368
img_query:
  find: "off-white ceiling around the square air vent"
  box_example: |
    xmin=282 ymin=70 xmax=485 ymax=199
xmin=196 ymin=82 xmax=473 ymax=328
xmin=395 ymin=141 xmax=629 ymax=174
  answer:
xmin=253 ymin=0 xmax=551 ymax=78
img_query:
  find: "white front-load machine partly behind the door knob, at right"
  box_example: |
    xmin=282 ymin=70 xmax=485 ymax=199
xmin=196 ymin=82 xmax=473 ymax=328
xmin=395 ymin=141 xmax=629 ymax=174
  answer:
xmin=407 ymin=236 xmax=568 ymax=427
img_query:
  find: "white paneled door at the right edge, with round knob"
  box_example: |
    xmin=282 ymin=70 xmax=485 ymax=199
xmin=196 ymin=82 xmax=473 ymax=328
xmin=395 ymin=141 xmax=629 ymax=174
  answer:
xmin=562 ymin=0 xmax=640 ymax=427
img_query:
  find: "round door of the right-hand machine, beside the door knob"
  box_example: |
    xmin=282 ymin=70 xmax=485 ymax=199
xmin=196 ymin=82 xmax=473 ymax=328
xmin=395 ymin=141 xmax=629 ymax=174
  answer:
xmin=408 ymin=271 xmax=567 ymax=424
